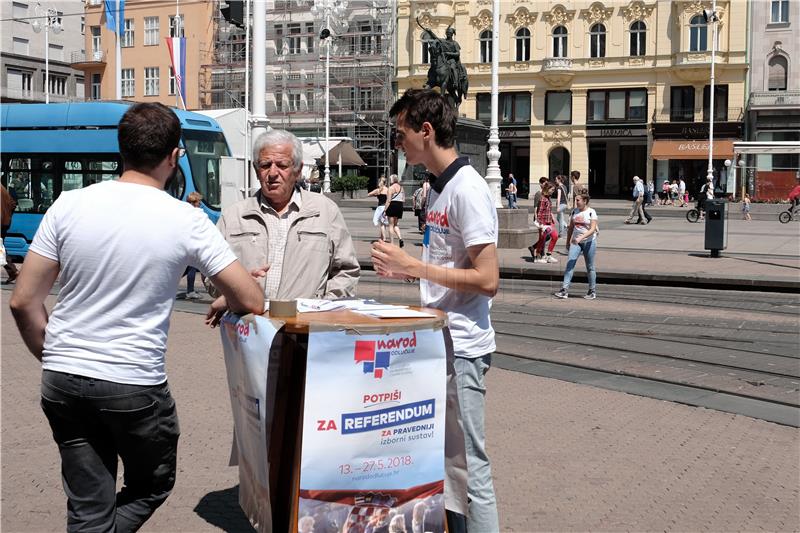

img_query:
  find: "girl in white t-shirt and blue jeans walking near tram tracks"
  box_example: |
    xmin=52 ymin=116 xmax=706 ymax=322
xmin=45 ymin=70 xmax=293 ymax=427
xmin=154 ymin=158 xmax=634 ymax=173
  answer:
xmin=554 ymin=193 xmax=597 ymax=300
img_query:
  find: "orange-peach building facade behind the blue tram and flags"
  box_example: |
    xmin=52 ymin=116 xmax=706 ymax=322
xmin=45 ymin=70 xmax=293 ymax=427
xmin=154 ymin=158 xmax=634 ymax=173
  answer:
xmin=72 ymin=0 xmax=216 ymax=109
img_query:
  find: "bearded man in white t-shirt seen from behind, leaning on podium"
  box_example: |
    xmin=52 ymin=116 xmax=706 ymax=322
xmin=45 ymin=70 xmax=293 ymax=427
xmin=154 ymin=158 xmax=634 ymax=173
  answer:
xmin=10 ymin=104 xmax=264 ymax=532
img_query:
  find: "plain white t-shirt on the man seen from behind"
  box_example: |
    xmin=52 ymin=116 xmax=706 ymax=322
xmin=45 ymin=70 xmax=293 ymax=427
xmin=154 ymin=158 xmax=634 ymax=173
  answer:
xmin=30 ymin=181 xmax=236 ymax=385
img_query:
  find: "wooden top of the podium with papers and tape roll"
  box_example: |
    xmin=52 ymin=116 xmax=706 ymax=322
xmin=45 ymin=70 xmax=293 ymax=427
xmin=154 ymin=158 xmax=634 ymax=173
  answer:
xmin=264 ymin=307 xmax=447 ymax=333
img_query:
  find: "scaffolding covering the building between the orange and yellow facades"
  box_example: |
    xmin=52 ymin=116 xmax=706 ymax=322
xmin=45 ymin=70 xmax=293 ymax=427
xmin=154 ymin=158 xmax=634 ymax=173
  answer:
xmin=201 ymin=0 xmax=395 ymax=179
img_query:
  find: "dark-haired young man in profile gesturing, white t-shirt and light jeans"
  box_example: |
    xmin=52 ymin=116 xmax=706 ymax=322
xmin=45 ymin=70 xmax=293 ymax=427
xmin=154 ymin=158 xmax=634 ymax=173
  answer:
xmin=372 ymin=89 xmax=499 ymax=532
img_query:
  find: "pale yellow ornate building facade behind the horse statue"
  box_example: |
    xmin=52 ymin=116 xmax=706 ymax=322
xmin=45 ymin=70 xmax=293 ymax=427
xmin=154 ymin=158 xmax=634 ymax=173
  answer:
xmin=397 ymin=0 xmax=748 ymax=197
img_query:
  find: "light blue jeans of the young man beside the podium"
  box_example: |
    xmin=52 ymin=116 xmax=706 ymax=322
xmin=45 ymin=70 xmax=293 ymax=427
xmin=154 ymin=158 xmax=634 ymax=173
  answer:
xmin=455 ymin=354 xmax=500 ymax=533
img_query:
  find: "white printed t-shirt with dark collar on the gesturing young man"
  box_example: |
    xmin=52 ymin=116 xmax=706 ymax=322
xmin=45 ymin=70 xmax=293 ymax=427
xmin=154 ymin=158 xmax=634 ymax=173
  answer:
xmin=420 ymin=158 xmax=498 ymax=358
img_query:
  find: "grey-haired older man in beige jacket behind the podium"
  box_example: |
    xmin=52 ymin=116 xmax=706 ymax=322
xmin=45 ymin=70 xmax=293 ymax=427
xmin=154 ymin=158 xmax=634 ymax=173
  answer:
xmin=217 ymin=130 xmax=360 ymax=300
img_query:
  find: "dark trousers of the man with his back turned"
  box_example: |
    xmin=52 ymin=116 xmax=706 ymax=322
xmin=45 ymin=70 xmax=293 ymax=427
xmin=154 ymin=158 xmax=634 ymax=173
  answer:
xmin=42 ymin=370 xmax=180 ymax=533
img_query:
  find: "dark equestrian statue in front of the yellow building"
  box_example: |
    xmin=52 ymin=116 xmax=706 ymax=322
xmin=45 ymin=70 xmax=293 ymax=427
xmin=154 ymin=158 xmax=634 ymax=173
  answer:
xmin=417 ymin=19 xmax=469 ymax=107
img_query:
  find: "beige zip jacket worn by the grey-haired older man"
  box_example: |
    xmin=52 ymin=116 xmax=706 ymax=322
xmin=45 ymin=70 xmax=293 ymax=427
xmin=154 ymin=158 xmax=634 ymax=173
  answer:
xmin=217 ymin=190 xmax=360 ymax=300
